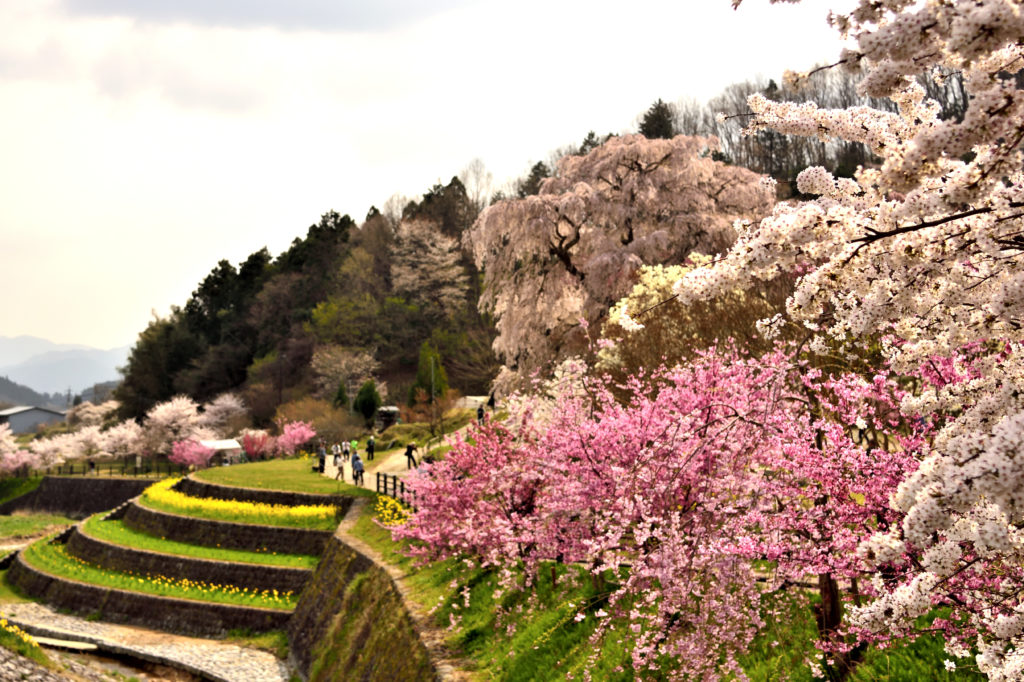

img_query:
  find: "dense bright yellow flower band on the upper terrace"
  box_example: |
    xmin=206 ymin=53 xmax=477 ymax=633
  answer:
xmin=142 ymin=478 xmax=337 ymax=530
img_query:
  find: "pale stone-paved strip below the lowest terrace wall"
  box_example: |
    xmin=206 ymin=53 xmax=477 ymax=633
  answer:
xmin=0 ymin=602 xmax=290 ymax=682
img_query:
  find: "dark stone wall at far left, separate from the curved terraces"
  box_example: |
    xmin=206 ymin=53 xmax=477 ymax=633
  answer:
xmin=0 ymin=476 xmax=155 ymax=518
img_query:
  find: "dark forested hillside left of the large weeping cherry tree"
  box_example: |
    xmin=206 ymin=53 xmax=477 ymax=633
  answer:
xmin=117 ymin=178 xmax=496 ymax=422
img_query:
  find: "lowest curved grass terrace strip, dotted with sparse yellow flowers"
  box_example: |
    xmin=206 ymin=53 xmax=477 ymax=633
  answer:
xmin=23 ymin=541 xmax=298 ymax=610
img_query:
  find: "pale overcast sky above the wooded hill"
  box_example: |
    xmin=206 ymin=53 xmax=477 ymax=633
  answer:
xmin=0 ymin=0 xmax=839 ymax=348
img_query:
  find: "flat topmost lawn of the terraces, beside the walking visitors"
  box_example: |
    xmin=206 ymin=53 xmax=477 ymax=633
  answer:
xmin=196 ymin=457 xmax=374 ymax=497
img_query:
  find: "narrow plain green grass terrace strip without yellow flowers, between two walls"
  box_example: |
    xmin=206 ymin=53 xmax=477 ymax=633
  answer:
xmin=83 ymin=515 xmax=319 ymax=568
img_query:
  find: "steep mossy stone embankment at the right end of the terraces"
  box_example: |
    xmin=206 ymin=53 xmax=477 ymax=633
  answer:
xmin=288 ymin=538 xmax=437 ymax=682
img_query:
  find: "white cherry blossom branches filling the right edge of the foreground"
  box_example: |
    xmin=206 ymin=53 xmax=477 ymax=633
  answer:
xmin=676 ymin=0 xmax=1024 ymax=680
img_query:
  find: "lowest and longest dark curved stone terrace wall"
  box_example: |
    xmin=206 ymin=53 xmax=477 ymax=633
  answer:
xmin=7 ymin=555 xmax=291 ymax=637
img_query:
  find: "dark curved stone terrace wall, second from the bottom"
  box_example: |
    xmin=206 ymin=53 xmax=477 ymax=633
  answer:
xmin=68 ymin=527 xmax=312 ymax=594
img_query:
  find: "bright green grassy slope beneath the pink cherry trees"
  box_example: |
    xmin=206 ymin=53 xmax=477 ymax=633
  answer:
xmin=353 ymin=499 xmax=985 ymax=682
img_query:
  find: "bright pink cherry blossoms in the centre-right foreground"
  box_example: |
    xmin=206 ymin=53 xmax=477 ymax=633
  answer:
xmin=393 ymin=349 xmax=924 ymax=679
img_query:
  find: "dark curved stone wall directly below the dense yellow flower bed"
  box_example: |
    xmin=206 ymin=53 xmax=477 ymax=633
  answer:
xmin=123 ymin=502 xmax=333 ymax=556
